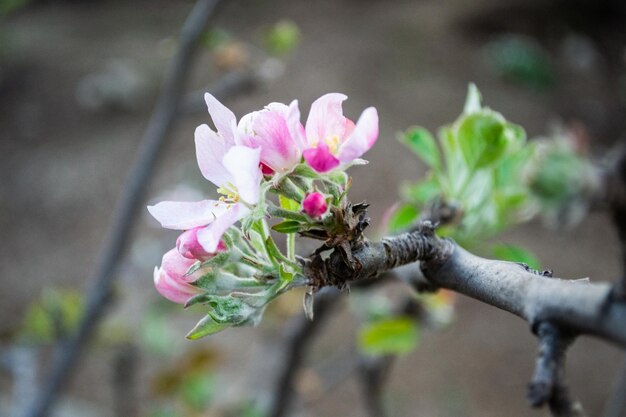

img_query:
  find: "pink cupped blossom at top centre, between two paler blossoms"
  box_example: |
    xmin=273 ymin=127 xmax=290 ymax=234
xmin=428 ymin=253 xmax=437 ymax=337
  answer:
xmin=237 ymin=100 xmax=305 ymax=174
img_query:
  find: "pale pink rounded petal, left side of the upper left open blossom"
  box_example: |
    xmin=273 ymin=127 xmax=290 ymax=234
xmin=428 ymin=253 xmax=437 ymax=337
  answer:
xmin=195 ymin=125 xmax=230 ymax=187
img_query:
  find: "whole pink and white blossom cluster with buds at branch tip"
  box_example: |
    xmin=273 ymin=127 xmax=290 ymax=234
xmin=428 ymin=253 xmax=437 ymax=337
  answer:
xmin=148 ymin=93 xmax=378 ymax=336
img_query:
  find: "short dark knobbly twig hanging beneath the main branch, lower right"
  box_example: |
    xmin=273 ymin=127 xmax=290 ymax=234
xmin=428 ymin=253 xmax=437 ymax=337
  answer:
xmin=528 ymin=322 xmax=586 ymax=417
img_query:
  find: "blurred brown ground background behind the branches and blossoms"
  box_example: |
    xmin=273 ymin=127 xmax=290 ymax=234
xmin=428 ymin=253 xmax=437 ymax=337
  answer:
xmin=0 ymin=0 xmax=626 ymax=417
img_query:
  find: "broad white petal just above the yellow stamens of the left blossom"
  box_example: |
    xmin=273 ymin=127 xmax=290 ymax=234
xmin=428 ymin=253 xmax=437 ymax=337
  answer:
xmin=224 ymin=146 xmax=263 ymax=204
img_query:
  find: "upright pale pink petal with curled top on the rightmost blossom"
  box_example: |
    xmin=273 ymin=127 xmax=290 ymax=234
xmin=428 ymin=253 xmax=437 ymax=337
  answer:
xmin=305 ymin=93 xmax=349 ymax=145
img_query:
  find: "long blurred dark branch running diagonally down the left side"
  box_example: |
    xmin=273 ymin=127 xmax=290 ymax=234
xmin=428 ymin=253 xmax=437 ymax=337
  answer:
xmin=25 ymin=0 xmax=227 ymax=417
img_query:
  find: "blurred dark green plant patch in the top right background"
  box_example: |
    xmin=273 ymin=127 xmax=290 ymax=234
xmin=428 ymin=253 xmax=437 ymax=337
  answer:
xmin=485 ymin=34 xmax=556 ymax=89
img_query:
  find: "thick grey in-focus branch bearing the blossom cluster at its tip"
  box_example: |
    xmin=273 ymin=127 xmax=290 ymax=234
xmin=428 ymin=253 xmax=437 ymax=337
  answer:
xmin=305 ymin=222 xmax=626 ymax=347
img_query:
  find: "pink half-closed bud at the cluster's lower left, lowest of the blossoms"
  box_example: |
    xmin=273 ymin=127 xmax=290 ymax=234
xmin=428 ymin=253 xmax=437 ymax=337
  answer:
xmin=154 ymin=249 xmax=202 ymax=304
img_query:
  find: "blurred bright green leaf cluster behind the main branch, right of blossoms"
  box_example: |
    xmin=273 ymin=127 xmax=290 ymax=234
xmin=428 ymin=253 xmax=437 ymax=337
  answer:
xmin=389 ymin=84 xmax=533 ymax=244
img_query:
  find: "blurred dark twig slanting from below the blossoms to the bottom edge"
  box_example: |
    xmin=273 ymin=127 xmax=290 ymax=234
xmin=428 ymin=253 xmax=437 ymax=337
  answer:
xmin=268 ymin=290 xmax=340 ymax=417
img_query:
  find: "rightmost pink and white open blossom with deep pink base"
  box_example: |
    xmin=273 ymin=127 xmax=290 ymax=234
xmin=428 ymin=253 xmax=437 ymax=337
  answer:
xmin=303 ymin=93 xmax=378 ymax=172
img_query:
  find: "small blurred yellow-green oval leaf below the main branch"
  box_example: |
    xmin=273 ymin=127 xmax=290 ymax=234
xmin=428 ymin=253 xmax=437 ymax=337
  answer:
xmin=358 ymin=317 xmax=419 ymax=356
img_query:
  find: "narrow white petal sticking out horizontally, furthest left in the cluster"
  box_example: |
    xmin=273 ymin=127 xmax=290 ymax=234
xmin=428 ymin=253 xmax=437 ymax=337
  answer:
xmin=148 ymin=200 xmax=226 ymax=230
